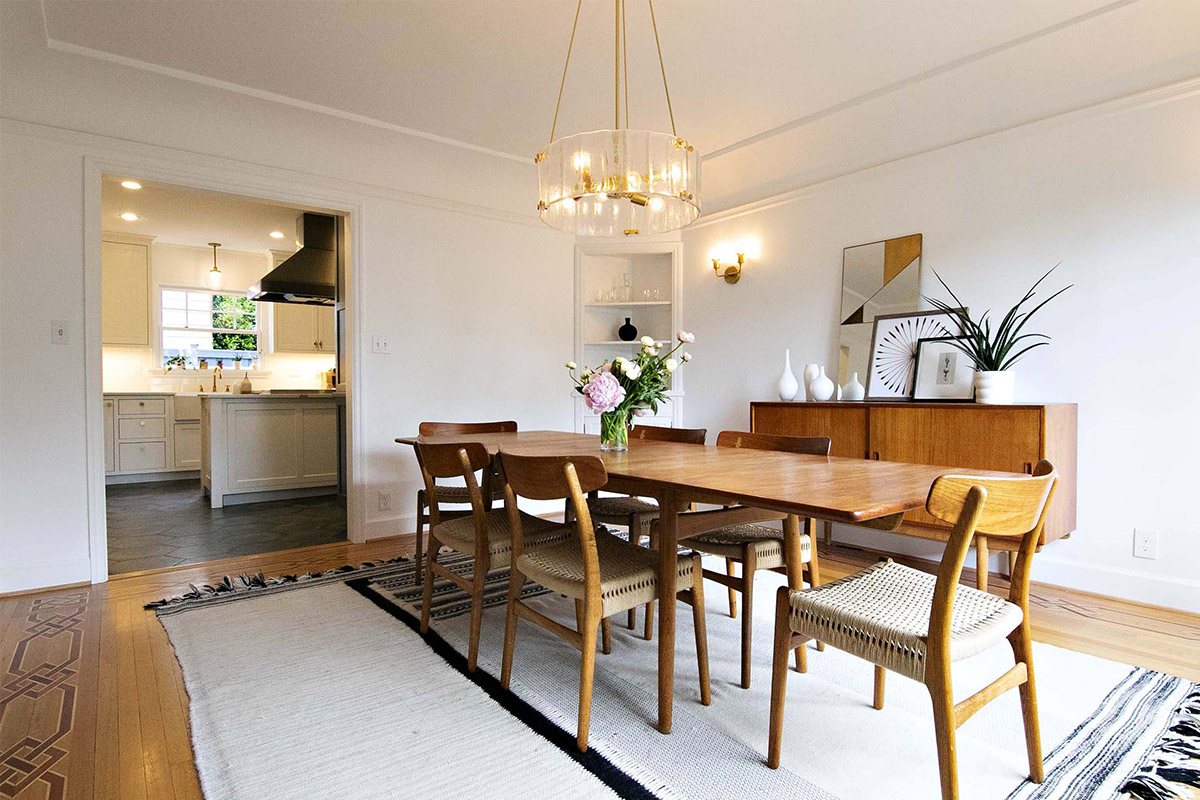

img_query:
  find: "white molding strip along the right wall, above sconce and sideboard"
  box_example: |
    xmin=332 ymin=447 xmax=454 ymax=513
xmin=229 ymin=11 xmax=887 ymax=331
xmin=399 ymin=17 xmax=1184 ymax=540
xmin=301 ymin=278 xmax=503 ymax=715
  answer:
xmin=685 ymin=76 xmax=1200 ymax=230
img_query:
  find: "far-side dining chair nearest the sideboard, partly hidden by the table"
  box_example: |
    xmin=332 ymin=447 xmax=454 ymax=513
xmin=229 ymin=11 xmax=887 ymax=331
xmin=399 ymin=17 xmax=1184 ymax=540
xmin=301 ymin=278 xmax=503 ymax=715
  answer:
xmin=679 ymin=431 xmax=830 ymax=688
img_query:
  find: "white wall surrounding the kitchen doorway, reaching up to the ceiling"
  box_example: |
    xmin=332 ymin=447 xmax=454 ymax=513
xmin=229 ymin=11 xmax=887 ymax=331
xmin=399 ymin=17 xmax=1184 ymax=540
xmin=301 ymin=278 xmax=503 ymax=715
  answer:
xmin=0 ymin=2 xmax=574 ymax=593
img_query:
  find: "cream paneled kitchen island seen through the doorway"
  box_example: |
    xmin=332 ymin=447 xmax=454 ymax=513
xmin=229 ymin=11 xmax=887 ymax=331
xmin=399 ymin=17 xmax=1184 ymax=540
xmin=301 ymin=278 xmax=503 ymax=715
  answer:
xmin=200 ymin=391 xmax=346 ymax=509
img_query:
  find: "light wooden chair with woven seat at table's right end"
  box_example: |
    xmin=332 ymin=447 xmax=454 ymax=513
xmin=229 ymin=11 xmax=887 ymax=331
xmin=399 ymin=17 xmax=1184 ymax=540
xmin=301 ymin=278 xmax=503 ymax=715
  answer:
xmin=767 ymin=461 xmax=1058 ymax=800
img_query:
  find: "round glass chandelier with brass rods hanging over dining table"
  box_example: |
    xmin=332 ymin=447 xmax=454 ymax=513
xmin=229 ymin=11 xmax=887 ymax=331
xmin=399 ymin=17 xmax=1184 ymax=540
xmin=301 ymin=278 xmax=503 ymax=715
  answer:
xmin=534 ymin=0 xmax=700 ymax=236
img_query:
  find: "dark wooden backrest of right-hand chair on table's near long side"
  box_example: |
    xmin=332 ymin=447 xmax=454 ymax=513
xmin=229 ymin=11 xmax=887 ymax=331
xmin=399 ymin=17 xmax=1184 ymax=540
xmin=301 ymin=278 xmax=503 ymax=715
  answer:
xmin=499 ymin=450 xmax=608 ymax=602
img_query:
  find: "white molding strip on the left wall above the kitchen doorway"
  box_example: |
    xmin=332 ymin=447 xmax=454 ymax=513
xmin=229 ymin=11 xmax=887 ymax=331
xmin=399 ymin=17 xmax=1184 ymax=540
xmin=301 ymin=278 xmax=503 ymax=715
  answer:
xmin=0 ymin=116 xmax=552 ymax=235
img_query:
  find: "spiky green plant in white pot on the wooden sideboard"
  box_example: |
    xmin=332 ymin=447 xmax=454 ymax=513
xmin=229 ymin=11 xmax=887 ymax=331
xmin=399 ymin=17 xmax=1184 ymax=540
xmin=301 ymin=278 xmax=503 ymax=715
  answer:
xmin=925 ymin=264 xmax=1074 ymax=405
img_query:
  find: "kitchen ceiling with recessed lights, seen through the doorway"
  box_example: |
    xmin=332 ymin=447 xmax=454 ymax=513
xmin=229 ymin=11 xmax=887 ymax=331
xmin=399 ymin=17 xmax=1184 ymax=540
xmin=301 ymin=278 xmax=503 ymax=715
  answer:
xmin=101 ymin=175 xmax=300 ymax=253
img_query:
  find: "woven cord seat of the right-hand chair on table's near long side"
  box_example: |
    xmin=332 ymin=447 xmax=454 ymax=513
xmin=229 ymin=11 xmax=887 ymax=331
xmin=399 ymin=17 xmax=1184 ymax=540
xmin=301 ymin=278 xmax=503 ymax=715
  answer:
xmin=517 ymin=533 xmax=694 ymax=616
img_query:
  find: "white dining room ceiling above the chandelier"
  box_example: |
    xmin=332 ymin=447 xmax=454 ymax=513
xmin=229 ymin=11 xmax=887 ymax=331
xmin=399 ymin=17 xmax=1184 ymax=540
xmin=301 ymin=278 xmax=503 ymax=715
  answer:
xmin=43 ymin=0 xmax=1200 ymax=211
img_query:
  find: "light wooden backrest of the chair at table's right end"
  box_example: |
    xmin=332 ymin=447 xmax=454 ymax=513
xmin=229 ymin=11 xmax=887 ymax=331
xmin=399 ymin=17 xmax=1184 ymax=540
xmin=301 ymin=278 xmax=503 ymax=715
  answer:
xmin=925 ymin=461 xmax=1058 ymax=664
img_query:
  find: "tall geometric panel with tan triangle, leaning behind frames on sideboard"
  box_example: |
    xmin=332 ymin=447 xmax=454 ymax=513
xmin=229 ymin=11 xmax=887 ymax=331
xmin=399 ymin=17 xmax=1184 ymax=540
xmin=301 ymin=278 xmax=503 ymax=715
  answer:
xmin=830 ymin=234 xmax=922 ymax=386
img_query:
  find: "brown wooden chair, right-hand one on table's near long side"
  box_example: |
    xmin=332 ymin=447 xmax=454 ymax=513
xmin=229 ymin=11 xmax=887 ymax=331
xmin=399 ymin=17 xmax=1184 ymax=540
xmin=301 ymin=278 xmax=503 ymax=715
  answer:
xmin=499 ymin=451 xmax=712 ymax=752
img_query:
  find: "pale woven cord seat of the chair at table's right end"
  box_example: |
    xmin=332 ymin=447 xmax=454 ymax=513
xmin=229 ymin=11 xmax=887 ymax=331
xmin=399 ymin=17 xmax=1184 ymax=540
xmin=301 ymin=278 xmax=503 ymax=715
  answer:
xmin=790 ymin=561 xmax=1024 ymax=681
